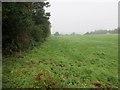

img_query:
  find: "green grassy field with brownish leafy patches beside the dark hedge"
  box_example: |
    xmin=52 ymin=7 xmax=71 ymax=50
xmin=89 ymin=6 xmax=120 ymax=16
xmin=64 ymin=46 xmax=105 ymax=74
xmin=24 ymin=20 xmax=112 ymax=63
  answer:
xmin=3 ymin=35 xmax=118 ymax=88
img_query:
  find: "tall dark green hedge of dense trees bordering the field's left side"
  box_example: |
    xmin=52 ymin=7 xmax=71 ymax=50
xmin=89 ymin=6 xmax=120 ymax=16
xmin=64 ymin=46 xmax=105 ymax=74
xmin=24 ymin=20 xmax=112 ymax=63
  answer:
xmin=2 ymin=2 xmax=50 ymax=55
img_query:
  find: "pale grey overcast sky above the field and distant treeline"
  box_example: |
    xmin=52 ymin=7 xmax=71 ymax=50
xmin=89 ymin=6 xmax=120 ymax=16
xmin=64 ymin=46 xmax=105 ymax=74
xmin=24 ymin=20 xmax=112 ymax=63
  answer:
xmin=47 ymin=0 xmax=118 ymax=34
